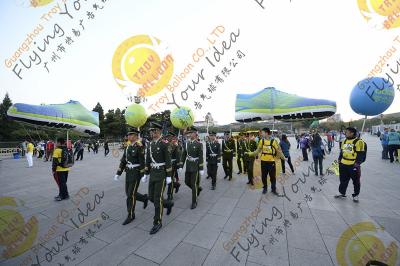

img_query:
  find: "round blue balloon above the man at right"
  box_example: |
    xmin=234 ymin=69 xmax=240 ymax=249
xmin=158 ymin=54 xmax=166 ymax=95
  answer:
xmin=350 ymin=77 xmax=394 ymax=116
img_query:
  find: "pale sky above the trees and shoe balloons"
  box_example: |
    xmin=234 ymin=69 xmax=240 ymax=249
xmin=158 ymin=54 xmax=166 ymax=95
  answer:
xmin=0 ymin=0 xmax=400 ymax=124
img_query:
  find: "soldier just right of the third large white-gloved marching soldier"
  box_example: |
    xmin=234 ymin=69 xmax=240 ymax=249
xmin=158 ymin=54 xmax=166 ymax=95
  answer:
xmin=206 ymin=132 xmax=221 ymax=190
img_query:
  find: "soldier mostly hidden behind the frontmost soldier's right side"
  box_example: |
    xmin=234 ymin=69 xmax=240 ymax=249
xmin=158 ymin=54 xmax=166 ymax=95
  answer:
xmin=167 ymin=132 xmax=181 ymax=200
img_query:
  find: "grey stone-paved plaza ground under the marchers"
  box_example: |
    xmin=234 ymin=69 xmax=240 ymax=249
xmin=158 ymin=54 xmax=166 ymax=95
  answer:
xmin=0 ymin=136 xmax=400 ymax=266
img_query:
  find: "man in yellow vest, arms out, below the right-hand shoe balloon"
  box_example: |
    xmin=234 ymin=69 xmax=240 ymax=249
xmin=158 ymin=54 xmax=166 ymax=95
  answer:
xmin=246 ymin=128 xmax=285 ymax=195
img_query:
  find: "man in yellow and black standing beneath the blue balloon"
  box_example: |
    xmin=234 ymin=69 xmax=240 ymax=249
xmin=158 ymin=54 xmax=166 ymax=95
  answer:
xmin=335 ymin=127 xmax=367 ymax=202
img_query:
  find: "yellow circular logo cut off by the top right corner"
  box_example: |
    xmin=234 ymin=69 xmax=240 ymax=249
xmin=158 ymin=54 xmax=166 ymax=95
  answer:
xmin=357 ymin=0 xmax=400 ymax=29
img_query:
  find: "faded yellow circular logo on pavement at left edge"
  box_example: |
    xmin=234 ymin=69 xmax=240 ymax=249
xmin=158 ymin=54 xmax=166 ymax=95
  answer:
xmin=0 ymin=197 xmax=39 ymax=258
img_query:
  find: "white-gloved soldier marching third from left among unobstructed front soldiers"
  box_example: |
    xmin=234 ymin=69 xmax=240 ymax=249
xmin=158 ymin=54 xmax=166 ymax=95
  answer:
xmin=179 ymin=127 xmax=204 ymax=209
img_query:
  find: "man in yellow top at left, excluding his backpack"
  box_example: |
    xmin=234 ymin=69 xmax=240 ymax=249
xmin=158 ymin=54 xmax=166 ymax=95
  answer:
xmin=52 ymin=138 xmax=69 ymax=201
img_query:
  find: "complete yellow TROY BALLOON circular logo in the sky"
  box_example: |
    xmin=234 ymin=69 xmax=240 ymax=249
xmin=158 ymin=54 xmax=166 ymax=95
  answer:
xmin=112 ymin=35 xmax=174 ymax=97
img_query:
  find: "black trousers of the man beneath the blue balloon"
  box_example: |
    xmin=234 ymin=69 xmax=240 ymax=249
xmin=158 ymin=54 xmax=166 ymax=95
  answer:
xmin=339 ymin=163 xmax=361 ymax=197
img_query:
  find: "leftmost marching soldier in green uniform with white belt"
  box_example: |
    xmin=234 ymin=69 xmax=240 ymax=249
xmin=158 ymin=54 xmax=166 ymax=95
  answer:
xmin=114 ymin=129 xmax=148 ymax=225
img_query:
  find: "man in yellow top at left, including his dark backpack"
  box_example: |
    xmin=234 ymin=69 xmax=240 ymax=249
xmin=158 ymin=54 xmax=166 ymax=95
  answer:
xmin=52 ymin=138 xmax=74 ymax=201
